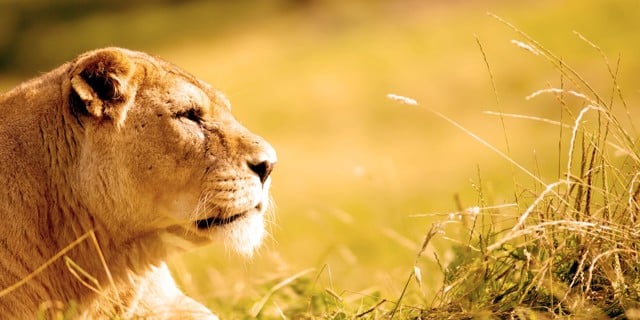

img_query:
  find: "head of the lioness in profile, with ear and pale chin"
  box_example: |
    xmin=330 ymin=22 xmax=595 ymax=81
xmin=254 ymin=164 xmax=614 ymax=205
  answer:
xmin=68 ymin=48 xmax=276 ymax=253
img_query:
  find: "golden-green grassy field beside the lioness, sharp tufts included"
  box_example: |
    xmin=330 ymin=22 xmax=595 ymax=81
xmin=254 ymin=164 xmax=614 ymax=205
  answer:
xmin=0 ymin=0 xmax=640 ymax=319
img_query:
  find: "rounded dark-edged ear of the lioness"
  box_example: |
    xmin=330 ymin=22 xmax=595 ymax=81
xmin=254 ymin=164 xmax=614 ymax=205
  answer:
xmin=71 ymin=49 xmax=133 ymax=121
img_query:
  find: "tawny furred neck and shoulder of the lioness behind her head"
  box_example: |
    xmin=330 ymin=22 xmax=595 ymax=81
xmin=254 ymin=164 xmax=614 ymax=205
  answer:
xmin=0 ymin=70 xmax=178 ymax=318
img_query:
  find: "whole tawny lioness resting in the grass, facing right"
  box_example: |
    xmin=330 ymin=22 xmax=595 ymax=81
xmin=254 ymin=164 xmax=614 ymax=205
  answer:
xmin=0 ymin=48 xmax=276 ymax=319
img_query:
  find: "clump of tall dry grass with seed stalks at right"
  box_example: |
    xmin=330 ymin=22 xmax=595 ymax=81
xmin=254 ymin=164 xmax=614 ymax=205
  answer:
xmin=396 ymin=15 xmax=640 ymax=319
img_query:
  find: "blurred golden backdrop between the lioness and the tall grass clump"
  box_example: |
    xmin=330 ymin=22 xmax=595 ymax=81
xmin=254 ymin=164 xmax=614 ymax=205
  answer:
xmin=0 ymin=0 xmax=640 ymax=319
